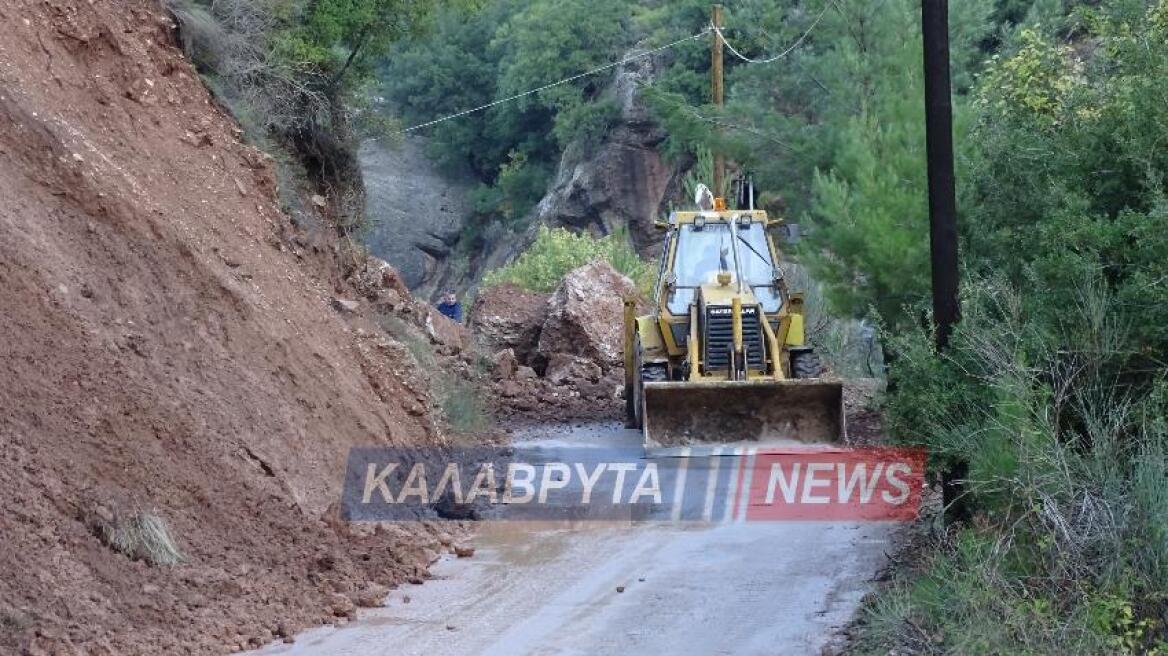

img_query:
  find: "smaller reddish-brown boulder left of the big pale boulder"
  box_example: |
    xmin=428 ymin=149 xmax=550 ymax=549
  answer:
xmin=471 ymin=285 xmax=548 ymax=365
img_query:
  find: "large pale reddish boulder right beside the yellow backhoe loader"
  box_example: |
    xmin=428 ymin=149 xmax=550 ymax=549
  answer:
xmin=538 ymin=261 xmax=637 ymax=371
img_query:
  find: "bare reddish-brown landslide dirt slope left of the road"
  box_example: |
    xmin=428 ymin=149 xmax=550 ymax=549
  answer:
xmin=0 ymin=0 xmax=448 ymax=654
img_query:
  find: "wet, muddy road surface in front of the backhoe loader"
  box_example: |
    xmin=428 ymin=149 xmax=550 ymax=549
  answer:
xmin=257 ymin=426 xmax=894 ymax=656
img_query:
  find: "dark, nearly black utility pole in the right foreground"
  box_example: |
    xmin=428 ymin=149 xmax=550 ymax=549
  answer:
xmin=920 ymin=0 xmax=961 ymax=350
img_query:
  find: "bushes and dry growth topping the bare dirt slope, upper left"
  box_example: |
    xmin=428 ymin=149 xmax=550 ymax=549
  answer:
xmin=166 ymin=0 xmax=458 ymax=231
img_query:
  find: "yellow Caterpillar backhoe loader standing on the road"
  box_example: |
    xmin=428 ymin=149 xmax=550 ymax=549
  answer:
xmin=624 ymin=189 xmax=844 ymax=447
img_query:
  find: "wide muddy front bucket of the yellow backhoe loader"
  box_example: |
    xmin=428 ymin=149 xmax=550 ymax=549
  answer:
xmin=644 ymin=379 xmax=844 ymax=447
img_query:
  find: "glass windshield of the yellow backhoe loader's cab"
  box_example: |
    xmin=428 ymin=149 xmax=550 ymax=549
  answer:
xmin=669 ymin=222 xmax=783 ymax=314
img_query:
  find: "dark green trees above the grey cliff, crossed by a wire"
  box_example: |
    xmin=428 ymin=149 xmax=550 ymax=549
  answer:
xmin=381 ymin=0 xmax=632 ymax=230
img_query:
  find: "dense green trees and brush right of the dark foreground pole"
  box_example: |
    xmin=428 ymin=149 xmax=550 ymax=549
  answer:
xmin=870 ymin=2 xmax=1168 ymax=654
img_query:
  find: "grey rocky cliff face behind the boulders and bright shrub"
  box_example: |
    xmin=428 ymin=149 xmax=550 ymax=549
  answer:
xmin=361 ymin=52 xmax=686 ymax=296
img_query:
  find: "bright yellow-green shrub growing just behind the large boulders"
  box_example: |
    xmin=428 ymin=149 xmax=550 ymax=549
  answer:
xmin=482 ymin=225 xmax=654 ymax=295
